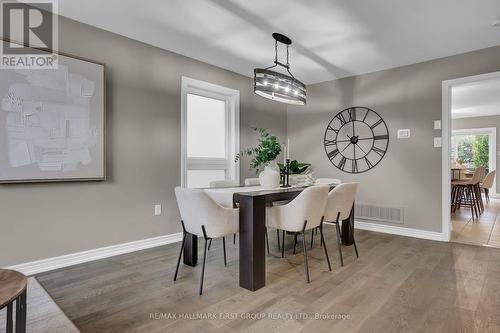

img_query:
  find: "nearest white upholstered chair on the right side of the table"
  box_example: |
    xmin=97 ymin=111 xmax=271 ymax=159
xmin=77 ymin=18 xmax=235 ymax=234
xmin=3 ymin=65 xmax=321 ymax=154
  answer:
xmin=266 ymin=185 xmax=332 ymax=283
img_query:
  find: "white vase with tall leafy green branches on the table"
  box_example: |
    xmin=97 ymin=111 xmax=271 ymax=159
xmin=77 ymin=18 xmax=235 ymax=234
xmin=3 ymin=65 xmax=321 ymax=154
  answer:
xmin=235 ymin=128 xmax=281 ymax=188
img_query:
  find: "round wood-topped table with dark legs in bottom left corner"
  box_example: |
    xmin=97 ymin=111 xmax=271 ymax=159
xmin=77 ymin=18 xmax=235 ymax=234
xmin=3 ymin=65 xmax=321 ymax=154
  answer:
xmin=0 ymin=269 xmax=28 ymax=333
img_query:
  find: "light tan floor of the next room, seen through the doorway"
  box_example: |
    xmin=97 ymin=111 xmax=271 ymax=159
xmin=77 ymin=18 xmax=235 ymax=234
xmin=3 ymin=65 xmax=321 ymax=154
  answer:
xmin=451 ymin=198 xmax=500 ymax=248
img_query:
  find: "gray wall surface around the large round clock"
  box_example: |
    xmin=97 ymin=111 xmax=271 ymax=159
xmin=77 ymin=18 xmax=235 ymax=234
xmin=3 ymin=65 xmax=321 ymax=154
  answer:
xmin=287 ymin=47 xmax=500 ymax=232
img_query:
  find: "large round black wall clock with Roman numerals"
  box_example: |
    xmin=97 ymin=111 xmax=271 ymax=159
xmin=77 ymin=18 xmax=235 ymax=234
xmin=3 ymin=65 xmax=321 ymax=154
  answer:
xmin=324 ymin=107 xmax=389 ymax=173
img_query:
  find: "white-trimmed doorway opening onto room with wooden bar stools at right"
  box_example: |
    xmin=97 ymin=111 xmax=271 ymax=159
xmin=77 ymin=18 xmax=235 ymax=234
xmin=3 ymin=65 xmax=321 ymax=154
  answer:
xmin=442 ymin=72 xmax=500 ymax=248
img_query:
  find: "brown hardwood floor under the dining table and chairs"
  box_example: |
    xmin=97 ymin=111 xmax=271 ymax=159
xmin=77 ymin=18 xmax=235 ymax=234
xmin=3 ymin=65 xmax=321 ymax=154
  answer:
xmin=37 ymin=226 xmax=500 ymax=333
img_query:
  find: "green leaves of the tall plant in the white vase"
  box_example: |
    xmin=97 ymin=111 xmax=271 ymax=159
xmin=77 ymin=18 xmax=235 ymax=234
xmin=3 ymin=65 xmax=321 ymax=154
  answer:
xmin=234 ymin=128 xmax=281 ymax=173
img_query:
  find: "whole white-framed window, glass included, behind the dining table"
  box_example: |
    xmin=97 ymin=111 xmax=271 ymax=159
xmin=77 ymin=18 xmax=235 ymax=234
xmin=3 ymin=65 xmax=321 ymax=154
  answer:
xmin=181 ymin=77 xmax=240 ymax=187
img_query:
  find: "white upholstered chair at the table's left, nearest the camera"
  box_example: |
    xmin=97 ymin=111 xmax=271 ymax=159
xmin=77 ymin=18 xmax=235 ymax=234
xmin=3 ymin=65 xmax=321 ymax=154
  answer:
xmin=174 ymin=187 xmax=239 ymax=295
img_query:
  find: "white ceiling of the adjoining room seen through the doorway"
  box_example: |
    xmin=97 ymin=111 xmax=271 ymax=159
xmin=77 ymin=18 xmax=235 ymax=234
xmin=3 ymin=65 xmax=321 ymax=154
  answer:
xmin=451 ymin=78 xmax=500 ymax=119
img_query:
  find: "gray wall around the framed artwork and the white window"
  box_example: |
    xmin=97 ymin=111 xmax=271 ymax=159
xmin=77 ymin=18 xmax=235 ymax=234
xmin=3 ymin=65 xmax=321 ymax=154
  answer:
xmin=0 ymin=18 xmax=286 ymax=266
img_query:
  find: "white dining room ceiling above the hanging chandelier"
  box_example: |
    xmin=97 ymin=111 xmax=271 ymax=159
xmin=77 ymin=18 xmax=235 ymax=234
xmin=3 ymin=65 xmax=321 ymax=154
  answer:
xmin=59 ymin=0 xmax=500 ymax=84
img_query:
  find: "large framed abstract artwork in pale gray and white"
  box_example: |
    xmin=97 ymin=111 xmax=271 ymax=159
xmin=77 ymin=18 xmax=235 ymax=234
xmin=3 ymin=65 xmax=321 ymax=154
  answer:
xmin=0 ymin=40 xmax=106 ymax=183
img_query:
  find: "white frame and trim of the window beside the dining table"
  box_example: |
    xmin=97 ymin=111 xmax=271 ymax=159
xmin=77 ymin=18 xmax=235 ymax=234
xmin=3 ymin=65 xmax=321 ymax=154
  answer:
xmin=181 ymin=76 xmax=240 ymax=187
